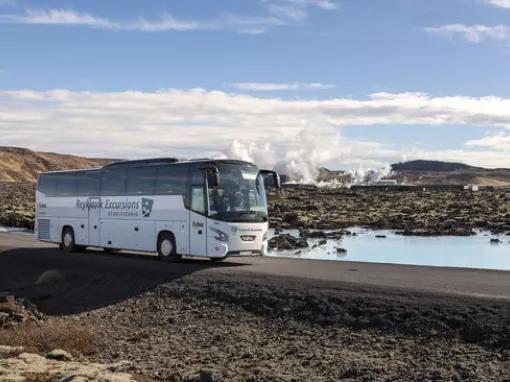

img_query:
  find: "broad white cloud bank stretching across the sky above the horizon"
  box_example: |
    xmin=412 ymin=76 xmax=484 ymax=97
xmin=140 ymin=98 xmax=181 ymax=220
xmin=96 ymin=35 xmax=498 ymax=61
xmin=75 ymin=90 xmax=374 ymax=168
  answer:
xmin=0 ymin=89 xmax=510 ymax=170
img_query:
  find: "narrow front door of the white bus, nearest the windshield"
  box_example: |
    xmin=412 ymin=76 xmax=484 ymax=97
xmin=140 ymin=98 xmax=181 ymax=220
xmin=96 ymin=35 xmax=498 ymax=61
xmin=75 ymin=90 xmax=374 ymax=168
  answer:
xmin=189 ymin=175 xmax=207 ymax=256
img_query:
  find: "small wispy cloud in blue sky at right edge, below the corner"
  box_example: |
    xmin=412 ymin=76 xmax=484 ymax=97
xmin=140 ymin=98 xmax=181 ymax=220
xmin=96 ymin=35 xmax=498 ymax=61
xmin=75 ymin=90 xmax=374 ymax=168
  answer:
xmin=425 ymin=24 xmax=510 ymax=43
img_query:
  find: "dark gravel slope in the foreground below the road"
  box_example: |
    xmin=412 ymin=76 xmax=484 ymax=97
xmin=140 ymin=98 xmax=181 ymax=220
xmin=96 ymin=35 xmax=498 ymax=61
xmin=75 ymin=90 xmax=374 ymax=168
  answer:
xmin=55 ymin=278 xmax=510 ymax=381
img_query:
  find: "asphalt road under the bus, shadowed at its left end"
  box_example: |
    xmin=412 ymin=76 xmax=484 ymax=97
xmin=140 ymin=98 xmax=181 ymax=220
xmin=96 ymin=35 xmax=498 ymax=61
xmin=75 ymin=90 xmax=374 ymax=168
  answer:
xmin=0 ymin=233 xmax=510 ymax=305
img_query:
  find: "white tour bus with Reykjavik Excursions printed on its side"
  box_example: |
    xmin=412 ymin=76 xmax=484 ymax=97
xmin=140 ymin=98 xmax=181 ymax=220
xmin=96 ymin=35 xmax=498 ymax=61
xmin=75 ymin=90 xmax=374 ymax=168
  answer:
xmin=35 ymin=158 xmax=280 ymax=261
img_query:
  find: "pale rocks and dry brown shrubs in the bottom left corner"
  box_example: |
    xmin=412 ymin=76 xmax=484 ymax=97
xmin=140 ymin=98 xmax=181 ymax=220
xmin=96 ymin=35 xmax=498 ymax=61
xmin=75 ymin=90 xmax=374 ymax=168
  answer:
xmin=0 ymin=292 xmax=148 ymax=382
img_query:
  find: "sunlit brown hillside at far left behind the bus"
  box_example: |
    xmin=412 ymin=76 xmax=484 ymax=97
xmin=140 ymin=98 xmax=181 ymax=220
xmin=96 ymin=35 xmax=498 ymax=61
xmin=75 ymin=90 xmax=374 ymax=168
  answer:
xmin=0 ymin=146 xmax=113 ymax=183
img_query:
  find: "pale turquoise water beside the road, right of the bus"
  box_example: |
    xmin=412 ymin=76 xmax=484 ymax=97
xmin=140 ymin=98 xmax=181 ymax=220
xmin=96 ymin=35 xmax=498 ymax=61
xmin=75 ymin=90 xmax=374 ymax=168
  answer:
xmin=269 ymin=228 xmax=510 ymax=270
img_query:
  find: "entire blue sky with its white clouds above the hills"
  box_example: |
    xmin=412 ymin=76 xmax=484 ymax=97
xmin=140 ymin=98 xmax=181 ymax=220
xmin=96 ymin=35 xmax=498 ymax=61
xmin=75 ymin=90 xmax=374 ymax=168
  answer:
xmin=0 ymin=0 xmax=510 ymax=174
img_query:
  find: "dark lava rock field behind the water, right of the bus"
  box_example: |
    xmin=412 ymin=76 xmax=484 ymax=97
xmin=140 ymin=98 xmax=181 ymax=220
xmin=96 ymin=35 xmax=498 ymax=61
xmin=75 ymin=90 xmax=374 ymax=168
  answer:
xmin=268 ymin=187 xmax=510 ymax=235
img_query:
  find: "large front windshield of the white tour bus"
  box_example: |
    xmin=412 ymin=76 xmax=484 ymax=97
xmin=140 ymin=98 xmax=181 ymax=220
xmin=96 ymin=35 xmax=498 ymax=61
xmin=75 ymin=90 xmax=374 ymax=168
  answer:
xmin=209 ymin=166 xmax=267 ymax=222
